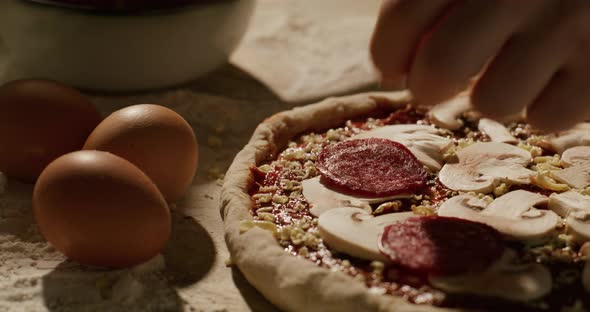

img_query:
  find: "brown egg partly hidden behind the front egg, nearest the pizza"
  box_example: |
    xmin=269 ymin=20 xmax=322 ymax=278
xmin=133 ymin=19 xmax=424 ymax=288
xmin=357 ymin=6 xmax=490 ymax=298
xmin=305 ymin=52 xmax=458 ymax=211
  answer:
xmin=84 ymin=104 xmax=198 ymax=202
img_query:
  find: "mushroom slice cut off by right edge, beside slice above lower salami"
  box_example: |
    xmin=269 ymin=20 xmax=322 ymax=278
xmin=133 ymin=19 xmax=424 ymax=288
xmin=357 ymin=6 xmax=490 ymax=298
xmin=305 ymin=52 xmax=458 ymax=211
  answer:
xmin=549 ymin=191 xmax=590 ymax=243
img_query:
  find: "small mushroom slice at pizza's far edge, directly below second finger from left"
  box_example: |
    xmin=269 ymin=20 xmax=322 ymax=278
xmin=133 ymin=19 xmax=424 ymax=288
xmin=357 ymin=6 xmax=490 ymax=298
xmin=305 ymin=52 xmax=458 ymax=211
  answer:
xmin=428 ymin=93 xmax=471 ymax=130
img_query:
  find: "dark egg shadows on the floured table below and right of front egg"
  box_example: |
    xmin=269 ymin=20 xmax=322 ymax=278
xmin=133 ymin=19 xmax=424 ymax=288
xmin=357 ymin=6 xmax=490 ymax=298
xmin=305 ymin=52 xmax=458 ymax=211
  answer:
xmin=42 ymin=213 xmax=216 ymax=312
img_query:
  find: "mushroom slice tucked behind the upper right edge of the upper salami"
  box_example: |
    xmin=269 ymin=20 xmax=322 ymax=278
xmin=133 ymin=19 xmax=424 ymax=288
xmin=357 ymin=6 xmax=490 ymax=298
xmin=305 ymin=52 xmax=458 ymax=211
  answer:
xmin=351 ymin=125 xmax=453 ymax=171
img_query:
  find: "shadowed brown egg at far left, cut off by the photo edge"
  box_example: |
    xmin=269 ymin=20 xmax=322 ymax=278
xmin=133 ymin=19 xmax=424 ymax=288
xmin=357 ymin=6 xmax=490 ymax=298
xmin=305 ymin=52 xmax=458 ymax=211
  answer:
xmin=0 ymin=80 xmax=101 ymax=182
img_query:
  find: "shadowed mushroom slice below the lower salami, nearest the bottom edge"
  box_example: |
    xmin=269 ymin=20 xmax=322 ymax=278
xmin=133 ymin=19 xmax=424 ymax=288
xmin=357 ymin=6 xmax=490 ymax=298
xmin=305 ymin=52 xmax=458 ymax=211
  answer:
xmin=429 ymin=250 xmax=552 ymax=302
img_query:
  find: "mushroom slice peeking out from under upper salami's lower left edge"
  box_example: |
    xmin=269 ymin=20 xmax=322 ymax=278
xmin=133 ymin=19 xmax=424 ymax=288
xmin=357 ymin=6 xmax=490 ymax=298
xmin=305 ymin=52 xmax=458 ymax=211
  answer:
xmin=301 ymin=177 xmax=412 ymax=217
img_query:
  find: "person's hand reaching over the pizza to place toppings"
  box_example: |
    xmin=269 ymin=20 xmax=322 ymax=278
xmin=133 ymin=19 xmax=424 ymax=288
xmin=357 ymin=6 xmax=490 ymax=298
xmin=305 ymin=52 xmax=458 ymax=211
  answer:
xmin=371 ymin=0 xmax=590 ymax=131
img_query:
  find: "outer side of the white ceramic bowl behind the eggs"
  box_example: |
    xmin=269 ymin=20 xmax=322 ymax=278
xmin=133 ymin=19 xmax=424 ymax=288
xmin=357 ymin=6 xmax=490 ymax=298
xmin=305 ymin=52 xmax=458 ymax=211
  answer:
xmin=0 ymin=0 xmax=255 ymax=91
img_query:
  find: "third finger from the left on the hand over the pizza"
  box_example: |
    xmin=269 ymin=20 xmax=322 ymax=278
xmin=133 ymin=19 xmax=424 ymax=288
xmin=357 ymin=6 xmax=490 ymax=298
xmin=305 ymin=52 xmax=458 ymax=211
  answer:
xmin=472 ymin=1 xmax=577 ymax=119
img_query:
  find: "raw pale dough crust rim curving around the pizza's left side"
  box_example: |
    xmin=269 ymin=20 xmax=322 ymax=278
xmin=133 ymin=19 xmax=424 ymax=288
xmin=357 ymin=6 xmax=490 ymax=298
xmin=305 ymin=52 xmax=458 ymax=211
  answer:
xmin=221 ymin=92 xmax=458 ymax=312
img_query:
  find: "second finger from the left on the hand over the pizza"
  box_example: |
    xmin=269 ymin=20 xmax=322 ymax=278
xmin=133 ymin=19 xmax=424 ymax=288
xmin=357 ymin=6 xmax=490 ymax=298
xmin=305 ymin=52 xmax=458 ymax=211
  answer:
xmin=408 ymin=0 xmax=526 ymax=105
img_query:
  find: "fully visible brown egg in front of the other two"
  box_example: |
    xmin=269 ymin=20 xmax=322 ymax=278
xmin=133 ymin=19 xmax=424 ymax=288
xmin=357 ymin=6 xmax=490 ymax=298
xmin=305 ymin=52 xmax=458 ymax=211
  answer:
xmin=33 ymin=151 xmax=170 ymax=268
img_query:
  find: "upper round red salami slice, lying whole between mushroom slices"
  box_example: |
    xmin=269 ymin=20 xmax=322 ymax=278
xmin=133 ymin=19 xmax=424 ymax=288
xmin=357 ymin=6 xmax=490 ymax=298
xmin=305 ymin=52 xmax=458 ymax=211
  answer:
xmin=316 ymin=138 xmax=427 ymax=197
